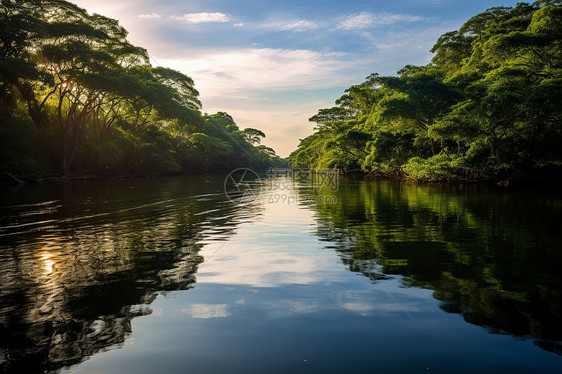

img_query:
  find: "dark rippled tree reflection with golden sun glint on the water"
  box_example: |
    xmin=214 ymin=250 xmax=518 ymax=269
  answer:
xmin=0 ymin=177 xmax=259 ymax=373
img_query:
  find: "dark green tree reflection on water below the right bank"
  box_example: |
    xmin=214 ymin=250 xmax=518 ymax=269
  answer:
xmin=301 ymin=181 xmax=562 ymax=354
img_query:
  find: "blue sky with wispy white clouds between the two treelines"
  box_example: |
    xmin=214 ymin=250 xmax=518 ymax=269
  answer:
xmin=71 ymin=0 xmax=517 ymax=157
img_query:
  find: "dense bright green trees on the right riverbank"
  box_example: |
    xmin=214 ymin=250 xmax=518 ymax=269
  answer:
xmin=289 ymin=0 xmax=562 ymax=181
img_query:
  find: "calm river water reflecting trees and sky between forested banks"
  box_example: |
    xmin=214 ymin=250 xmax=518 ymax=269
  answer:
xmin=0 ymin=177 xmax=562 ymax=373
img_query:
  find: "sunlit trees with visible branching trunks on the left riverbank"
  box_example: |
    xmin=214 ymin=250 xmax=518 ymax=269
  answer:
xmin=0 ymin=0 xmax=283 ymax=177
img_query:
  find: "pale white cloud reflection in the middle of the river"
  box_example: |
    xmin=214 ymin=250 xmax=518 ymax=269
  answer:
xmin=197 ymin=199 xmax=341 ymax=287
